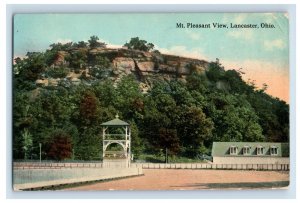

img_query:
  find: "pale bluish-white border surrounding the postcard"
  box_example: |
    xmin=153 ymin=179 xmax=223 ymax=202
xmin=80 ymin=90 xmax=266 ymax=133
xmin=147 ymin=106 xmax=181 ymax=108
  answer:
xmin=0 ymin=0 xmax=300 ymax=199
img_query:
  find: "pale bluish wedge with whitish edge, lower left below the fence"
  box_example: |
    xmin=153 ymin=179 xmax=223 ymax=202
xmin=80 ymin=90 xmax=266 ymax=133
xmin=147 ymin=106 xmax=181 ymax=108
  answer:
xmin=13 ymin=168 xmax=143 ymax=191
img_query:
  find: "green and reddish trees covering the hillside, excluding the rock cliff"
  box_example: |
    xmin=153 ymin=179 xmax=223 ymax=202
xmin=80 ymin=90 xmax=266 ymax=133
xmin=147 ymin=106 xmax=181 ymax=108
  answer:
xmin=13 ymin=38 xmax=289 ymax=160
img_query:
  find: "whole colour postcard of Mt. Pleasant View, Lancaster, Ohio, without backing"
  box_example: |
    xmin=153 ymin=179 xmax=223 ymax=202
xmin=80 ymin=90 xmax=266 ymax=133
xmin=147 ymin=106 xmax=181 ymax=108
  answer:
xmin=12 ymin=13 xmax=290 ymax=191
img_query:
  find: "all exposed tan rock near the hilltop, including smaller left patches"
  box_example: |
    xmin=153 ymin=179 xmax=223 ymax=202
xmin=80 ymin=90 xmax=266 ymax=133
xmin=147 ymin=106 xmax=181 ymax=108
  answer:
xmin=36 ymin=48 xmax=209 ymax=90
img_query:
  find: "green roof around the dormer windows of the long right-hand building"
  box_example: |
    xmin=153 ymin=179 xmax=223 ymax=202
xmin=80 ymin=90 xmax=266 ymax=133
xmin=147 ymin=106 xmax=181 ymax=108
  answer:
xmin=211 ymin=142 xmax=289 ymax=157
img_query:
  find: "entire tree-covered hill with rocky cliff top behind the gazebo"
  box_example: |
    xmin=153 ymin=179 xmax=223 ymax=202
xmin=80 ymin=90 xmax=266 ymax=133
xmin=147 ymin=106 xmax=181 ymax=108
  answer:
xmin=13 ymin=36 xmax=289 ymax=160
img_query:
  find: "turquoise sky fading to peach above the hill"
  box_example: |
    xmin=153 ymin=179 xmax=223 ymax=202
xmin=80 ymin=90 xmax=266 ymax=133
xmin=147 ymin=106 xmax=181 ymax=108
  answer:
xmin=13 ymin=13 xmax=289 ymax=103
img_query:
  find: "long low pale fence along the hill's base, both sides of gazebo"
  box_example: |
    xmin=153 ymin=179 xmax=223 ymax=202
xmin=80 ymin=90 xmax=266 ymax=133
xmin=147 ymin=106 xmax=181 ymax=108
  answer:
xmin=13 ymin=162 xmax=290 ymax=171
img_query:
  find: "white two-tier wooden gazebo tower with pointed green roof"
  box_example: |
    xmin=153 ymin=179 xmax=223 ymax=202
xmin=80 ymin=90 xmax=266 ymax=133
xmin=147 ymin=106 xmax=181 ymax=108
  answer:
xmin=101 ymin=115 xmax=131 ymax=167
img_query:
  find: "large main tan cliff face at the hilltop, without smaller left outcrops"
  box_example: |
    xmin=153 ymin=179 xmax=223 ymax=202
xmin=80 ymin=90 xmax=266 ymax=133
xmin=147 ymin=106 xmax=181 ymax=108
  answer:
xmin=103 ymin=49 xmax=208 ymax=83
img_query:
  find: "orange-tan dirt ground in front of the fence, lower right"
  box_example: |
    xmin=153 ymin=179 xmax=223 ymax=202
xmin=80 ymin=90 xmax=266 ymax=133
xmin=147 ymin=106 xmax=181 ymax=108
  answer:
xmin=64 ymin=169 xmax=289 ymax=190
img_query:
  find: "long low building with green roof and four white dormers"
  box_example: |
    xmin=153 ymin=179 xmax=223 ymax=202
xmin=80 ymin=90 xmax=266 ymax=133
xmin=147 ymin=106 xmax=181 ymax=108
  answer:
xmin=212 ymin=142 xmax=289 ymax=164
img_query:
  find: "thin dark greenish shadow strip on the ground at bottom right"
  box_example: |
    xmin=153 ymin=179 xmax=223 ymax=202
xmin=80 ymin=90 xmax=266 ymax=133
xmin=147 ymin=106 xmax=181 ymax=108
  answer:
xmin=172 ymin=181 xmax=290 ymax=189
